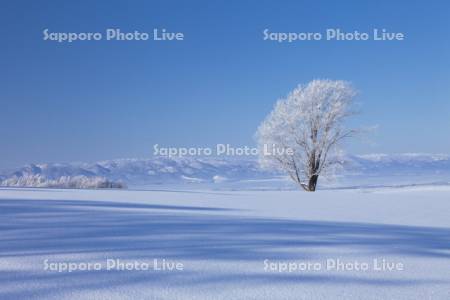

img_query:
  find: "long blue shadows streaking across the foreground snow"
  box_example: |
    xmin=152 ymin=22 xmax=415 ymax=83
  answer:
xmin=0 ymin=200 xmax=450 ymax=298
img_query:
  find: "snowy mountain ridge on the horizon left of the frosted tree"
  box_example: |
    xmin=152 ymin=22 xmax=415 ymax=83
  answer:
xmin=0 ymin=157 xmax=276 ymax=186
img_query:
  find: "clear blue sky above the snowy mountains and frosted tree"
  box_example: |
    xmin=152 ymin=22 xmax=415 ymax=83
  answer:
xmin=0 ymin=0 xmax=450 ymax=167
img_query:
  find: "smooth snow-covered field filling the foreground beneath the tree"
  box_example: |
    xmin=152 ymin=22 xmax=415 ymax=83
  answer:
xmin=0 ymin=186 xmax=450 ymax=299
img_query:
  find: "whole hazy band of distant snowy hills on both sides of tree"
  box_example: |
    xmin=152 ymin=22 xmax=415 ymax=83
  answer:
xmin=0 ymin=154 xmax=450 ymax=190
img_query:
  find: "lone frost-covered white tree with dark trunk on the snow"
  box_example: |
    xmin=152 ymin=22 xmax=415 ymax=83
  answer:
xmin=256 ymin=80 xmax=356 ymax=192
